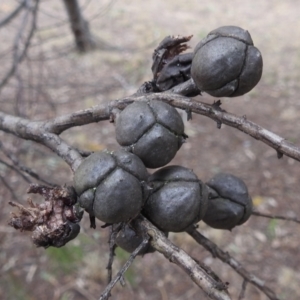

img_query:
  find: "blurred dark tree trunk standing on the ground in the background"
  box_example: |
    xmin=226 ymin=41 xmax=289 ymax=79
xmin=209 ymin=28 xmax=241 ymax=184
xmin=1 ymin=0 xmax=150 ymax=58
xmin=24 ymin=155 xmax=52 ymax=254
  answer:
xmin=63 ymin=0 xmax=96 ymax=52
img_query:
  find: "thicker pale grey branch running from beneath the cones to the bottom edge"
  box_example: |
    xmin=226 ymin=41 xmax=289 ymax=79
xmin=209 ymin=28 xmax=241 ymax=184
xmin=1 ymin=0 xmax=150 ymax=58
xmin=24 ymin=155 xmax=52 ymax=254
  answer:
xmin=133 ymin=216 xmax=231 ymax=300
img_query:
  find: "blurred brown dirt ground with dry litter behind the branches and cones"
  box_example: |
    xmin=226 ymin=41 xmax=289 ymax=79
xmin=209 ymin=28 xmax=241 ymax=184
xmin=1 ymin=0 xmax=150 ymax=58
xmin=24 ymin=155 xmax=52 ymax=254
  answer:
xmin=0 ymin=0 xmax=300 ymax=300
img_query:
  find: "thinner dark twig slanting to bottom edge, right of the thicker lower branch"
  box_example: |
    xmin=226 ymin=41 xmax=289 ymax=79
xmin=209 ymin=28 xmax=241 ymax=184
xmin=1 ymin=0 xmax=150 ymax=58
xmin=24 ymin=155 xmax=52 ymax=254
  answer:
xmin=186 ymin=226 xmax=280 ymax=300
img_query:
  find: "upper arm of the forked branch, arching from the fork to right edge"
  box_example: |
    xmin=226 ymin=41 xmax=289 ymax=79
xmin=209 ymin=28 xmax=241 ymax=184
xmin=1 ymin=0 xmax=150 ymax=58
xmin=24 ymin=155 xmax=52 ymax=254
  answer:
xmin=47 ymin=93 xmax=300 ymax=161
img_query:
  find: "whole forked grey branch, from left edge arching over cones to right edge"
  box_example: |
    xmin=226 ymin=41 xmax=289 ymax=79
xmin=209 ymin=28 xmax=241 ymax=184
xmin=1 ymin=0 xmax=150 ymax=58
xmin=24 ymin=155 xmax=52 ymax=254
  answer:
xmin=0 ymin=88 xmax=300 ymax=171
